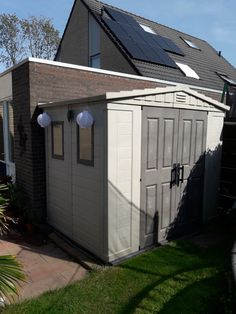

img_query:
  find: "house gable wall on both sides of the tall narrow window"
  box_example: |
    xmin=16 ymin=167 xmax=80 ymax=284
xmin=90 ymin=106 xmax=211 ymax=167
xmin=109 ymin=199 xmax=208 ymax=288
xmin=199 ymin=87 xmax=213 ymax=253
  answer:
xmin=56 ymin=1 xmax=138 ymax=74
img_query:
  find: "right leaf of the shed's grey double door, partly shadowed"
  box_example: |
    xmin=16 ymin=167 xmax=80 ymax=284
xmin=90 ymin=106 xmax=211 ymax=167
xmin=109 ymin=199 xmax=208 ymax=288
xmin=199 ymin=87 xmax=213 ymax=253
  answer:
xmin=173 ymin=110 xmax=207 ymax=238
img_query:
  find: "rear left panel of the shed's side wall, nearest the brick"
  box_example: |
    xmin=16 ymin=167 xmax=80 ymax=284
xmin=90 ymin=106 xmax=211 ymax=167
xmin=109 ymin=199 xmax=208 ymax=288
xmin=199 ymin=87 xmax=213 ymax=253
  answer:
xmin=46 ymin=109 xmax=72 ymax=237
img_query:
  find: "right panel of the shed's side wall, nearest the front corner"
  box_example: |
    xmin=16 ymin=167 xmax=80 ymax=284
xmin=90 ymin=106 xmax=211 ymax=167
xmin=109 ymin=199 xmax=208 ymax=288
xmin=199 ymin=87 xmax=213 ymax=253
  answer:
xmin=71 ymin=104 xmax=106 ymax=258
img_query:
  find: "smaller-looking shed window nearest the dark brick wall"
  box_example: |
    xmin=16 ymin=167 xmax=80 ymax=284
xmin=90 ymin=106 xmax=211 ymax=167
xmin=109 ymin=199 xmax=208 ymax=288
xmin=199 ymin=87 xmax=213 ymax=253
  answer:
xmin=52 ymin=122 xmax=64 ymax=159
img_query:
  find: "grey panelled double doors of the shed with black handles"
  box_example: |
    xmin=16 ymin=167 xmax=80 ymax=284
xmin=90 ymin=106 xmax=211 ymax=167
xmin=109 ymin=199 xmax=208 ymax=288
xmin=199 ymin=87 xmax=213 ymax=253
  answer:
xmin=140 ymin=107 xmax=207 ymax=248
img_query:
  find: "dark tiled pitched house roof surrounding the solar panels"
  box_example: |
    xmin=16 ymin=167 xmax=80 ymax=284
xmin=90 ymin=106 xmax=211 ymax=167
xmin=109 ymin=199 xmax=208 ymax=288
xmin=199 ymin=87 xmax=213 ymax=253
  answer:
xmin=78 ymin=0 xmax=236 ymax=90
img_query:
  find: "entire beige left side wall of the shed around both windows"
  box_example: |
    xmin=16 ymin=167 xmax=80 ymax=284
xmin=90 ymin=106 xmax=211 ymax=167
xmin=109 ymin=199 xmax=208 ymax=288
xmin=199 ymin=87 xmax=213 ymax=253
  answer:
xmin=45 ymin=104 xmax=107 ymax=260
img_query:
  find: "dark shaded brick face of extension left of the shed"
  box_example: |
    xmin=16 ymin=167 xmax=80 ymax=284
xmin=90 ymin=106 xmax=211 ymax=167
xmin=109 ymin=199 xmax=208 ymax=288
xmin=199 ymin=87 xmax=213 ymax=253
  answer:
xmin=12 ymin=63 xmax=39 ymax=212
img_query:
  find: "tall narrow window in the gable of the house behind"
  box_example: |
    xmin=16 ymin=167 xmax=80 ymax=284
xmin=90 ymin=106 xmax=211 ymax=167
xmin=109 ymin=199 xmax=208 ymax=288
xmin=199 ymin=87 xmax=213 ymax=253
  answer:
xmin=89 ymin=15 xmax=101 ymax=69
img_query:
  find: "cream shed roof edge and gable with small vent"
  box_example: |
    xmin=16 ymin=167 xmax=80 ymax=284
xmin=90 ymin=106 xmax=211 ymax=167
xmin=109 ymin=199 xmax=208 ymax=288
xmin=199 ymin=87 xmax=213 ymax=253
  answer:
xmin=39 ymin=85 xmax=229 ymax=112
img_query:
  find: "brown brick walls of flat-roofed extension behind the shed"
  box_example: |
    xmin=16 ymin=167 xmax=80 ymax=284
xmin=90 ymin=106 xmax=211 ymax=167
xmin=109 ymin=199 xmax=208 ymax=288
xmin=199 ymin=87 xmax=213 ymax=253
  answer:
xmin=12 ymin=62 xmax=161 ymax=221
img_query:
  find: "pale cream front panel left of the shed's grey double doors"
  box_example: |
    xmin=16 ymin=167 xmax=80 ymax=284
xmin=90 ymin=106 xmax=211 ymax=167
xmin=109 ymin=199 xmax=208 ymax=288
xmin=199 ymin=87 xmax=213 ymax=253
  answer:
xmin=107 ymin=104 xmax=142 ymax=261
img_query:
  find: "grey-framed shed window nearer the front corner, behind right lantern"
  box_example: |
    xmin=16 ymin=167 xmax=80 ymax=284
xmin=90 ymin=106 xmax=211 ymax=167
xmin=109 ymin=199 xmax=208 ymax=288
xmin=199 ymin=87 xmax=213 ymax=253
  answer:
xmin=77 ymin=126 xmax=94 ymax=166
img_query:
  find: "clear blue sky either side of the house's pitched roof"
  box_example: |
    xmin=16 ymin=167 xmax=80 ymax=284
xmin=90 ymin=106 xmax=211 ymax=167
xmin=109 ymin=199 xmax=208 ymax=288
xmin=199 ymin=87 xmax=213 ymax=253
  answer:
xmin=0 ymin=0 xmax=236 ymax=70
